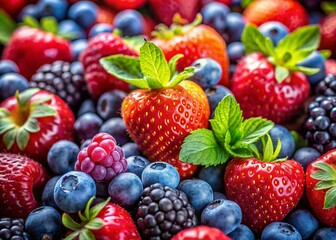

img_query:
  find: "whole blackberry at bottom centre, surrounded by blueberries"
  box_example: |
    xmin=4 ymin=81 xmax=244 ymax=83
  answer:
xmin=136 ymin=183 xmax=196 ymax=240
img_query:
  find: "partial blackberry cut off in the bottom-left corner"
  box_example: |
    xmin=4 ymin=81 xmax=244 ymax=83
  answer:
xmin=0 ymin=218 xmax=30 ymax=240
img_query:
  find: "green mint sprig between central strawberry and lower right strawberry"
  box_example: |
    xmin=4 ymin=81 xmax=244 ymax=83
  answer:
xmin=180 ymin=95 xmax=274 ymax=166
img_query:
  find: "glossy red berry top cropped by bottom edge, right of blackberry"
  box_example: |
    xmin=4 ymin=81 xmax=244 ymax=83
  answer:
xmin=171 ymin=225 xmax=230 ymax=240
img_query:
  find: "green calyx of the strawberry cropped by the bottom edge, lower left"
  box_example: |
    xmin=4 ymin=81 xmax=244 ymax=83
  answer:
xmin=62 ymin=197 xmax=111 ymax=240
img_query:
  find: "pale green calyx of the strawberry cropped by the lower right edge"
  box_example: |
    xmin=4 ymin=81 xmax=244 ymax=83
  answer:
xmin=311 ymin=161 xmax=336 ymax=209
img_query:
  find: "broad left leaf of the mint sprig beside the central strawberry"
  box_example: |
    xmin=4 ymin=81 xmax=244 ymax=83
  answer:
xmin=180 ymin=129 xmax=229 ymax=166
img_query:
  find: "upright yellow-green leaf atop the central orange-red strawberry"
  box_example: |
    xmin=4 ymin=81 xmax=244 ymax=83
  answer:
xmin=139 ymin=42 xmax=170 ymax=88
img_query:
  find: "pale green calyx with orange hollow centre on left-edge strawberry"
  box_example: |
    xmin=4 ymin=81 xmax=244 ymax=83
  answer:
xmin=0 ymin=88 xmax=57 ymax=150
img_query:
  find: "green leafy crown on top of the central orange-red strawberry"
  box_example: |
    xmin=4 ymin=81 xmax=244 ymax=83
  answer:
xmin=100 ymin=42 xmax=195 ymax=89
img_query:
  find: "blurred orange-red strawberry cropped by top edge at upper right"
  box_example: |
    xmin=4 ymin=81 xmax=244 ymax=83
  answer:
xmin=243 ymin=0 xmax=309 ymax=31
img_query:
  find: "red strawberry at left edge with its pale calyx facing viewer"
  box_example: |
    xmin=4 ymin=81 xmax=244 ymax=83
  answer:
xmin=0 ymin=88 xmax=74 ymax=163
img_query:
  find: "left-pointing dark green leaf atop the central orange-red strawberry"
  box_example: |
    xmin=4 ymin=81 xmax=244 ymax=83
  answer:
xmin=100 ymin=54 xmax=149 ymax=88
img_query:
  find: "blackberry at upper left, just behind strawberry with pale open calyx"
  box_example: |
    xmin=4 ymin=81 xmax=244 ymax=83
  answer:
xmin=30 ymin=61 xmax=87 ymax=109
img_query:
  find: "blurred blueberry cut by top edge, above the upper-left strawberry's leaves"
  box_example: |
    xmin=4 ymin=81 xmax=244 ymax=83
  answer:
xmin=36 ymin=0 xmax=68 ymax=21
